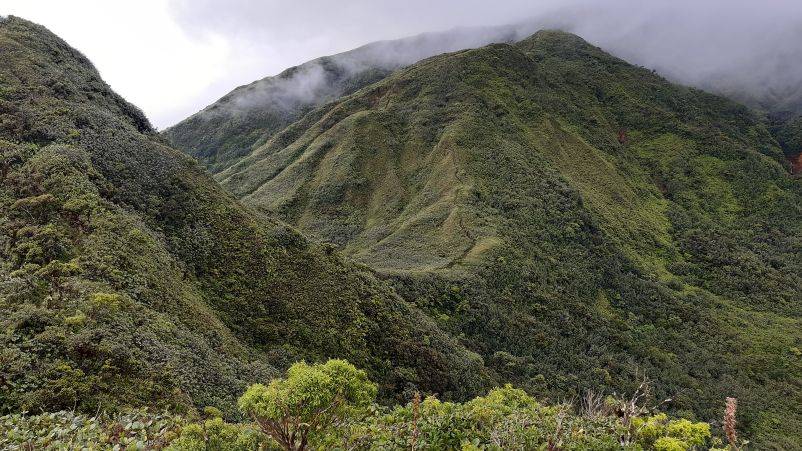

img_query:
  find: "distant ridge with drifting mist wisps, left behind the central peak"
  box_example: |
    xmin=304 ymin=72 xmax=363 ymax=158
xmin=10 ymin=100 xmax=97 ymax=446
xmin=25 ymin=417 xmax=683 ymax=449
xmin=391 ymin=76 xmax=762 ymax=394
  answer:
xmin=163 ymin=24 xmax=536 ymax=173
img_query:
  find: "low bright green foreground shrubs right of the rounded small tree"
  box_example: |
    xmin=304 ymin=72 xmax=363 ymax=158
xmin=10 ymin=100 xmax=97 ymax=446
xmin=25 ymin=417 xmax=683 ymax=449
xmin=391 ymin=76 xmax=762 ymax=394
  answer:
xmin=266 ymin=370 xmax=710 ymax=450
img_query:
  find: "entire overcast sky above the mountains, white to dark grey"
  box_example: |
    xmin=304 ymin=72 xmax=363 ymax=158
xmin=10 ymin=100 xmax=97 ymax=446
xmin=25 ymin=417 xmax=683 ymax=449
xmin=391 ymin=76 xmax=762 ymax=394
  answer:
xmin=0 ymin=0 xmax=802 ymax=128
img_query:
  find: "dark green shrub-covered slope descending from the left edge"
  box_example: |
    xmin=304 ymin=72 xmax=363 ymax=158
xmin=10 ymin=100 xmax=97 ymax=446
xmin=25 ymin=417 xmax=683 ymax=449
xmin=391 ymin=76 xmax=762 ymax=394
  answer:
xmin=0 ymin=17 xmax=490 ymax=420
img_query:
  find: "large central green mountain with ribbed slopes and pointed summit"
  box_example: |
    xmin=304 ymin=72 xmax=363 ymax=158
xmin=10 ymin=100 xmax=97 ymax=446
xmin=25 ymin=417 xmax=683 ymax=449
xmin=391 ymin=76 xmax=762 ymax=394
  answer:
xmin=166 ymin=31 xmax=802 ymax=449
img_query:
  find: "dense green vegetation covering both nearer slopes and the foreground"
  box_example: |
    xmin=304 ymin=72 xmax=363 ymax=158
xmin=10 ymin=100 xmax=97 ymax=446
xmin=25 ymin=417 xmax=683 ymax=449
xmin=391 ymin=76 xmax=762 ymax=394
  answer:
xmin=0 ymin=17 xmax=802 ymax=449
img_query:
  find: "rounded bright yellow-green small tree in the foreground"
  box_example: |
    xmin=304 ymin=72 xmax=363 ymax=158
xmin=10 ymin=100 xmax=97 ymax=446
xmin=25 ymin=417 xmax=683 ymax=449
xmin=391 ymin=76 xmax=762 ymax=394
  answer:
xmin=239 ymin=360 xmax=377 ymax=451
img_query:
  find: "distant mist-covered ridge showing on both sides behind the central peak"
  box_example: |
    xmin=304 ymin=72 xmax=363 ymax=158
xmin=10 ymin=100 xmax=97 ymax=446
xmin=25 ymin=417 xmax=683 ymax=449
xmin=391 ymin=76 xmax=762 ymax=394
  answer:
xmin=162 ymin=26 xmax=802 ymax=180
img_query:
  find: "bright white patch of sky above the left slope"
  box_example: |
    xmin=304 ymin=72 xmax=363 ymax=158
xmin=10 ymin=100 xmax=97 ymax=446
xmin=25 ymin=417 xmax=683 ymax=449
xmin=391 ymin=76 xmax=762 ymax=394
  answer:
xmin=0 ymin=0 xmax=230 ymax=127
